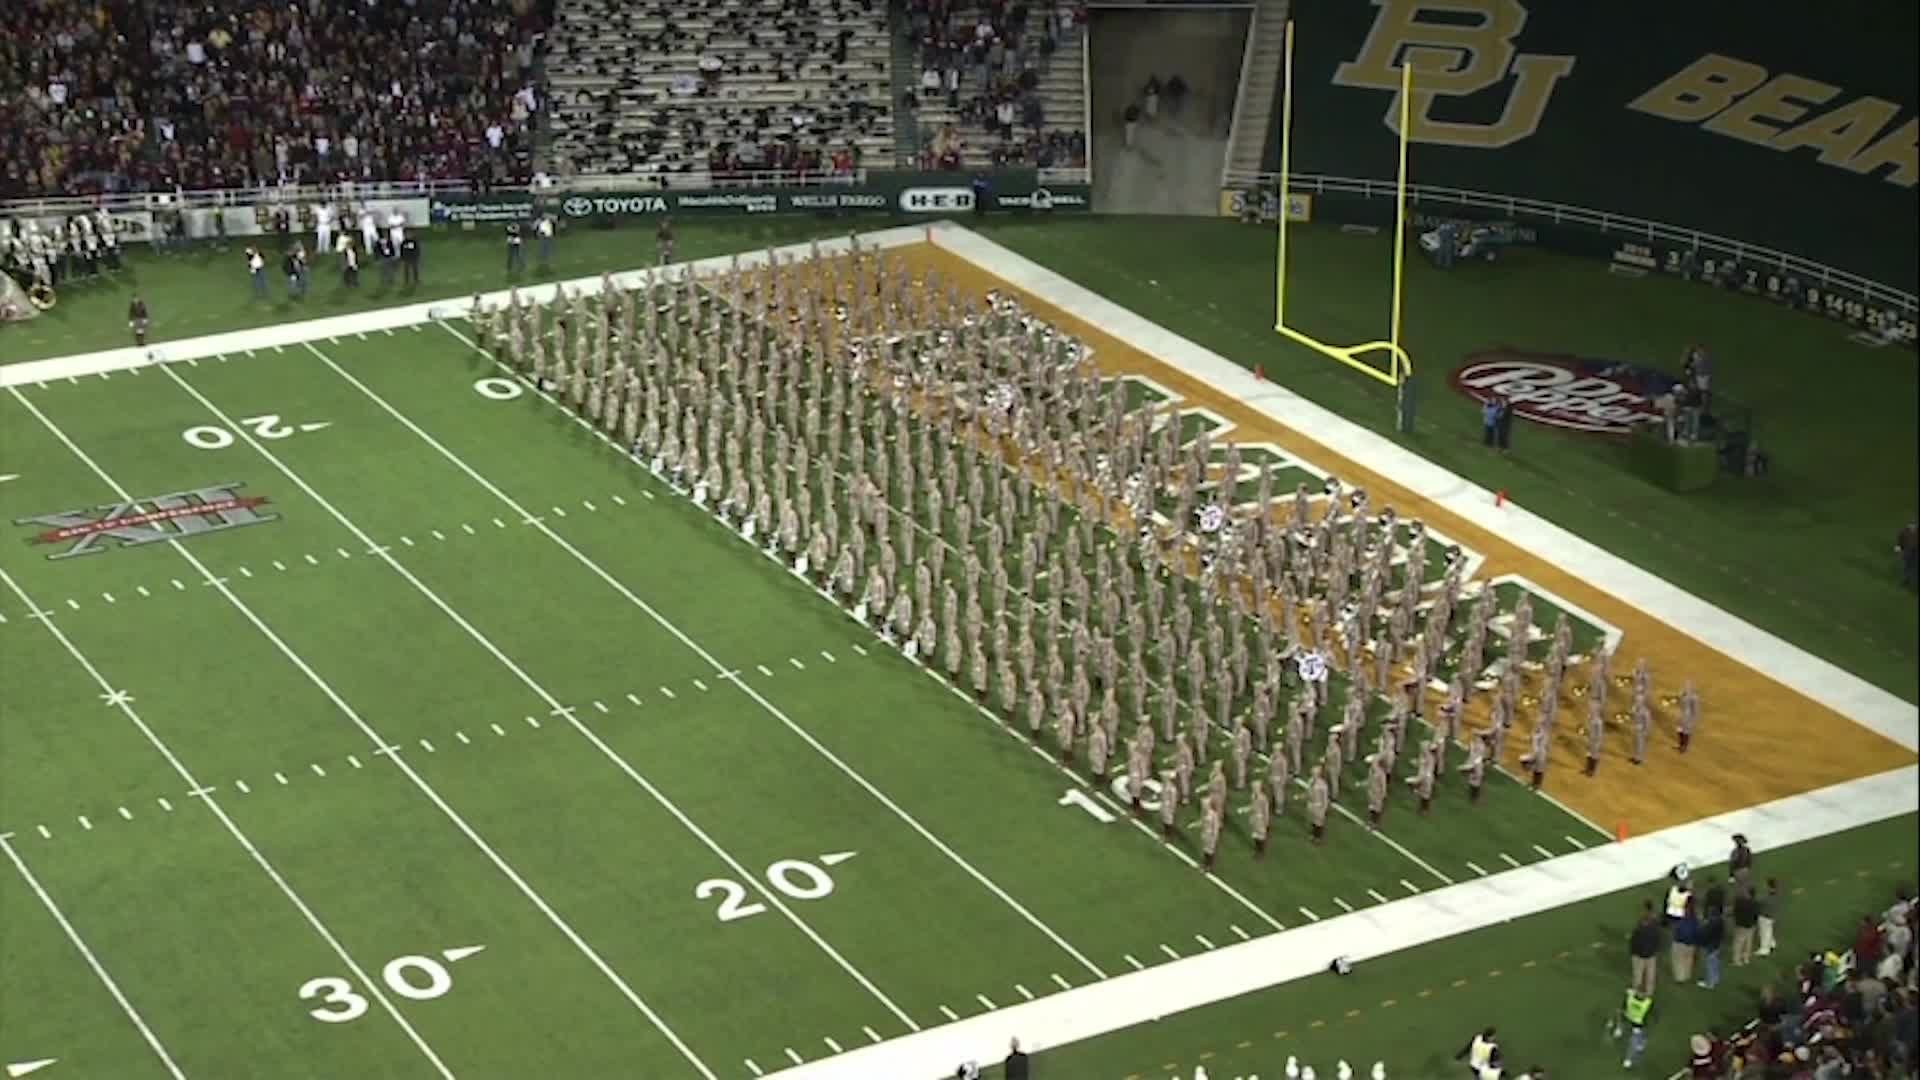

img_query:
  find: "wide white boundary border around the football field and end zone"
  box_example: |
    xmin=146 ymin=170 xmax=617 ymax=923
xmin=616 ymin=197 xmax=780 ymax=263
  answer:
xmin=0 ymin=223 xmax=1920 ymax=1080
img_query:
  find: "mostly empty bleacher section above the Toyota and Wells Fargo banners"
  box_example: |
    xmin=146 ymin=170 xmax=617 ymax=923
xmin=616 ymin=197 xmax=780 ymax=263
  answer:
xmin=547 ymin=0 xmax=895 ymax=186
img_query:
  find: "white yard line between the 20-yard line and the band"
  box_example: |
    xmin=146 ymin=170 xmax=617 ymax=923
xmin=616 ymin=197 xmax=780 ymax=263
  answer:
xmin=336 ymin=332 xmax=1106 ymax=980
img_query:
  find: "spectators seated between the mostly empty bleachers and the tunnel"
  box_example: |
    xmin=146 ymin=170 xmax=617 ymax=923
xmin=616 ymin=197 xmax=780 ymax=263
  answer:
xmin=902 ymin=0 xmax=1087 ymax=169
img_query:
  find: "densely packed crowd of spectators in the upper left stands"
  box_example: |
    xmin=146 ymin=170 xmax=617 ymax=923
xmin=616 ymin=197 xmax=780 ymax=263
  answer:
xmin=0 ymin=0 xmax=551 ymax=198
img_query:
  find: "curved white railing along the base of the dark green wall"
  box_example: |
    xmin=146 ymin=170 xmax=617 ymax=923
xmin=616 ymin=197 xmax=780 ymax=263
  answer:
xmin=1225 ymin=169 xmax=1920 ymax=317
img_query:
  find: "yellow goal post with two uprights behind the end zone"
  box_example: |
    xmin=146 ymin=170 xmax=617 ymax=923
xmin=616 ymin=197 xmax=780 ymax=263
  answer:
xmin=1273 ymin=19 xmax=1413 ymax=432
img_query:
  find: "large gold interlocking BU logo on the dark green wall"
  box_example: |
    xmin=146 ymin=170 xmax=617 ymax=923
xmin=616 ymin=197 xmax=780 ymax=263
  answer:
xmin=1332 ymin=0 xmax=1574 ymax=150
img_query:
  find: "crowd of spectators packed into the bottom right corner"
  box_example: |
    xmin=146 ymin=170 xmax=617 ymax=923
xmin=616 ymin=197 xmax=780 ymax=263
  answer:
xmin=1692 ymin=888 xmax=1920 ymax=1080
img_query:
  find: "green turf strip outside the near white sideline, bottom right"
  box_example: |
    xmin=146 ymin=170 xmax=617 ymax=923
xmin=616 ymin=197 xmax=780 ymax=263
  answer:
xmin=990 ymin=817 xmax=1920 ymax=1080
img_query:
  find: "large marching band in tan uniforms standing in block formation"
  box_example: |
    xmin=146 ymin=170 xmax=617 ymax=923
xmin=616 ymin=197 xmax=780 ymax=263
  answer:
xmin=470 ymin=246 xmax=1699 ymax=869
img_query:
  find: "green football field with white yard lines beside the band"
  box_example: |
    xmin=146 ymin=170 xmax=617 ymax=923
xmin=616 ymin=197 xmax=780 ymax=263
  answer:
xmin=0 ymin=222 xmax=1904 ymax=1078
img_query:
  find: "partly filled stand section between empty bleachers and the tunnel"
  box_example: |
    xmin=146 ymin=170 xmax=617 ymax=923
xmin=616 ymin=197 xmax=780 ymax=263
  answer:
xmin=906 ymin=0 xmax=1087 ymax=169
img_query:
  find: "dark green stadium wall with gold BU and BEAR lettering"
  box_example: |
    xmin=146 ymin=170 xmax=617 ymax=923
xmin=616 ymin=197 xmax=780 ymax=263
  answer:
xmin=1267 ymin=0 xmax=1920 ymax=290
